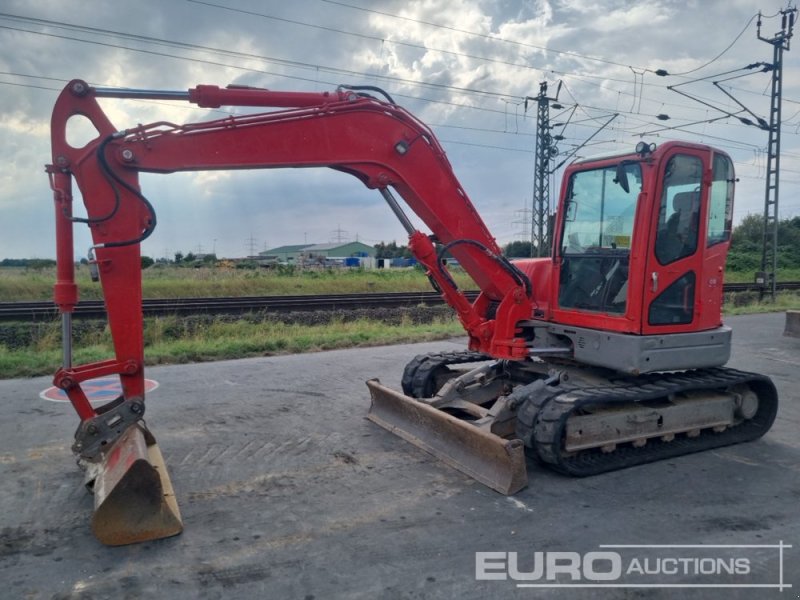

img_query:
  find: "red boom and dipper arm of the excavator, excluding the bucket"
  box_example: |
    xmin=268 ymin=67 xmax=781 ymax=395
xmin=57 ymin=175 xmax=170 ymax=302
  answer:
xmin=49 ymin=81 xmax=532 ymax=380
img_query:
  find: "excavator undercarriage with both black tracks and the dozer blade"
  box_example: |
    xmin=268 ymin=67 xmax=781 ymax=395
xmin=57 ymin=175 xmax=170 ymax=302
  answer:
xmin=367 ymin=352 xmax=777 ymax=494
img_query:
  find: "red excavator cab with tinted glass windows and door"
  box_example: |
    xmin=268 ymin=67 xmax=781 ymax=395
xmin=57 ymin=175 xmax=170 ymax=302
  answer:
xmin=552 ymin=142 xmax=734 ymax=335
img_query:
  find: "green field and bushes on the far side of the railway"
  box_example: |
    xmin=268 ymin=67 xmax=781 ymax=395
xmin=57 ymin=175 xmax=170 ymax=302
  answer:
xmin=0 ymin=215 xmax=800 ymax=302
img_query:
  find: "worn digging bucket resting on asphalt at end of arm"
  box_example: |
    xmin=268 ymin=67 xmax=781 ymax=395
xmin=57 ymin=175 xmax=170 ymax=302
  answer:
xmin=92 ymin=424 xmax=183 ymax=546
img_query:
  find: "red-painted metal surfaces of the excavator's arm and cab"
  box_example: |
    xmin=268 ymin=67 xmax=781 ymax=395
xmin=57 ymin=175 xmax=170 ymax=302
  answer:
xmin=48 ymin=81 xmax=727 ymax=419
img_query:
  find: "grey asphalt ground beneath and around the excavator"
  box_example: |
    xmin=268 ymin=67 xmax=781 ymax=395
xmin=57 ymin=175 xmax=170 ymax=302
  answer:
xmin=0 ymin=314 xmax=800 ymax=600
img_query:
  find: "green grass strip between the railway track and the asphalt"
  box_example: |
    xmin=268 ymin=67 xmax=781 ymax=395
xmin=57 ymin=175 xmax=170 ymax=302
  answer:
xmin=0 ymin=292 xmax=800 ymax=379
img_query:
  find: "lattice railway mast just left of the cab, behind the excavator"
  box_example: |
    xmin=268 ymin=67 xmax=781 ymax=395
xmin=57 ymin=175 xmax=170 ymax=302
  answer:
xmin=525 ymin=81 xmax=563 ymax=256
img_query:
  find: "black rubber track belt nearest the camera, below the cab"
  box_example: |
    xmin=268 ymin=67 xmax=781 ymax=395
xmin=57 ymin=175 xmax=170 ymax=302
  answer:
xmin=515 ymin=368 xmax=778 ymax=477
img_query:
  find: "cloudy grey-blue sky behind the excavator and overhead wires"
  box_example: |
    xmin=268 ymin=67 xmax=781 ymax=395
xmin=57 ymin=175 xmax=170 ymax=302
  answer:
xmin=0 ymin=0 xmax=800 ymax=258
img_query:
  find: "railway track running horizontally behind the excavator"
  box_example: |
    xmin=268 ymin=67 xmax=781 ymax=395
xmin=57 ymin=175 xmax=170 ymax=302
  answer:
xmin=0 ymin=281 xmax=800 ymax=321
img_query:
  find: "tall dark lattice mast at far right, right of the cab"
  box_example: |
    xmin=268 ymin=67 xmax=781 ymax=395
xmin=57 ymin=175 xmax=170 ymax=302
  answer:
xmin=756 ymin=8 xmax=797 ymax=302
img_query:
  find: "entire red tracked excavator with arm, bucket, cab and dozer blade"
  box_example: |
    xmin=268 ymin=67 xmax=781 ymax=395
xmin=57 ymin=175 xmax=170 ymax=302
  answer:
xmin=47 ymin=80 xmax=777 ymax=544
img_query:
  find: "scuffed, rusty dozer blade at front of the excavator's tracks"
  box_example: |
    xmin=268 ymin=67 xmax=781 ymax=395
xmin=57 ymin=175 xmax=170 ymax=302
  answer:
xmin=367 ymin=379 xmax=528 ymax=495
